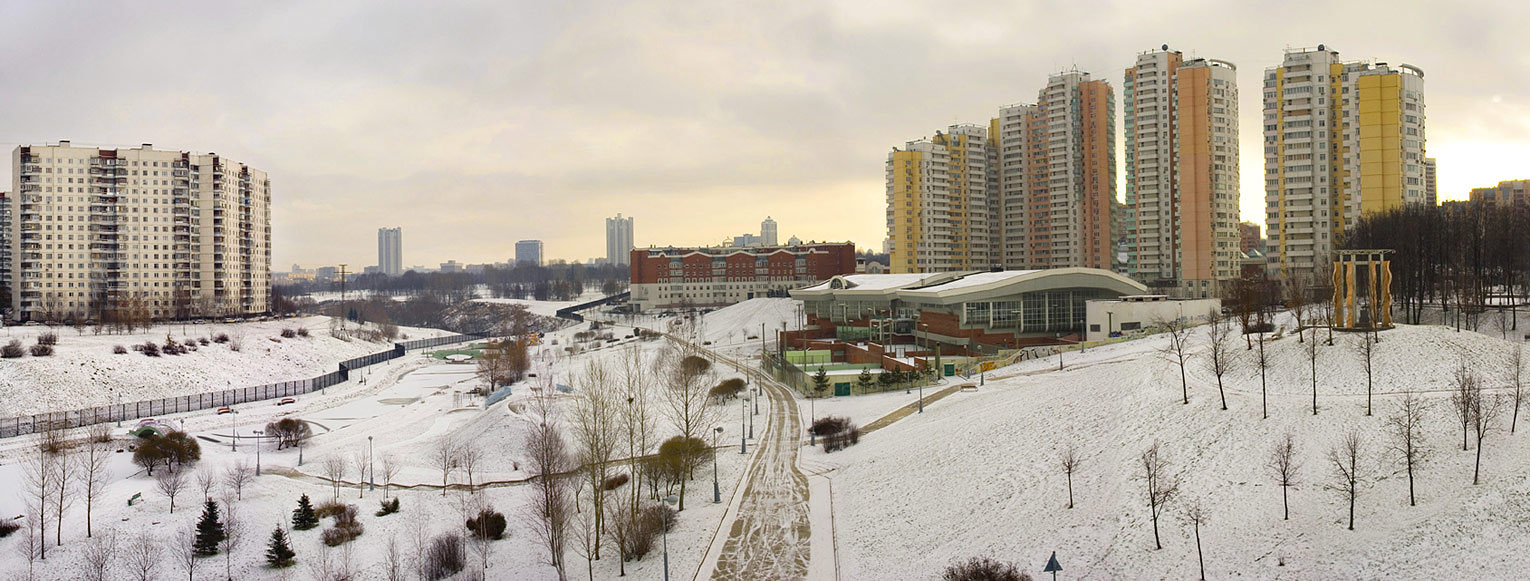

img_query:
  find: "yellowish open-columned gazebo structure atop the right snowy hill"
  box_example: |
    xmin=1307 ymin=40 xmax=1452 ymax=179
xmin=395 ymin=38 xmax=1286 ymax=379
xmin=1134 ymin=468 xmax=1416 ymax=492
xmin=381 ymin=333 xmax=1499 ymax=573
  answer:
xmin=1333 ymin=251 xmax=1392 ymax=330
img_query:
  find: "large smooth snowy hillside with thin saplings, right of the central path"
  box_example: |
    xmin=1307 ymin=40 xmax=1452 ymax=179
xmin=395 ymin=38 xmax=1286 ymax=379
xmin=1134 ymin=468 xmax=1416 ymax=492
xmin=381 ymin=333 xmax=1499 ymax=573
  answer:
xmin=809 ymin=319 xmax=1530 ymax=579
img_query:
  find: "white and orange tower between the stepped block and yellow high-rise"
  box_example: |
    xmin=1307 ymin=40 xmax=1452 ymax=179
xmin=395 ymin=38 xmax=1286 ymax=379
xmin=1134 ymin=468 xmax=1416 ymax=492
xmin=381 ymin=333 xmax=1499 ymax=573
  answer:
xmin=1121 ymin=46 xmax=1239 ymax=298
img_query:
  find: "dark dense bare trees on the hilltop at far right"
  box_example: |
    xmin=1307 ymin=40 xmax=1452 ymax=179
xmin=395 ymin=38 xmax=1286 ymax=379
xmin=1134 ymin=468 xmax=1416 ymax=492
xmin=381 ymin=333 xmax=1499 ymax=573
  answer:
xmin=1343 ymin=203 xmax=1530 ymax=327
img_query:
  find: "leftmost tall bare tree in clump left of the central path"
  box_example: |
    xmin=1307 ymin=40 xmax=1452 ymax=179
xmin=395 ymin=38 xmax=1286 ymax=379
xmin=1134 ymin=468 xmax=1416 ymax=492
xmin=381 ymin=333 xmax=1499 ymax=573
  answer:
xmin=526 ymin=383 xmax=574 ymax=581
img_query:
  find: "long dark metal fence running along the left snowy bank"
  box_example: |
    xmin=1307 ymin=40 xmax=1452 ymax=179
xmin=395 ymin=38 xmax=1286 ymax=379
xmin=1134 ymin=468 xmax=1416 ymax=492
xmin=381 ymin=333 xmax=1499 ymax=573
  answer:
xmin=0 ymin=335 xmax=483 ymax=437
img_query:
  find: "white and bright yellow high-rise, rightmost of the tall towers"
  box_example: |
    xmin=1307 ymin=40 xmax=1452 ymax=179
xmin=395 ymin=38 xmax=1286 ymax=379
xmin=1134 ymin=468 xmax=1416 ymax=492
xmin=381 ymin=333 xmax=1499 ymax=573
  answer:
xmin=1264 ymin=46 xmax=1427 ymax=278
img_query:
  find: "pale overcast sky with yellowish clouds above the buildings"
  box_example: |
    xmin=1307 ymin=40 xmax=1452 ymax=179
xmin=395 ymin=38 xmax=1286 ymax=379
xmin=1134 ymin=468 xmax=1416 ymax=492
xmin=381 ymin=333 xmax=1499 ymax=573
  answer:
xmin=0 ymin=0 xmax=1530 ymax=271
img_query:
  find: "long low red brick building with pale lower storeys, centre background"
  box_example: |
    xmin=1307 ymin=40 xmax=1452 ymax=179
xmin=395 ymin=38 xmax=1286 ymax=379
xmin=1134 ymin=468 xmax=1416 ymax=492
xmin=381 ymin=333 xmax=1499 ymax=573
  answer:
xmin=630 ymin=242 xmax=855 ymax=310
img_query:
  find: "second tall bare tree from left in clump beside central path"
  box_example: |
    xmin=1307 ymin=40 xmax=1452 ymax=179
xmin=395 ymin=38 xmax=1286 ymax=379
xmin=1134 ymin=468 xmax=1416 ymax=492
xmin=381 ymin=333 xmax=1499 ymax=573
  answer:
xmin=574 ymin=359 xmax=621 ymax=560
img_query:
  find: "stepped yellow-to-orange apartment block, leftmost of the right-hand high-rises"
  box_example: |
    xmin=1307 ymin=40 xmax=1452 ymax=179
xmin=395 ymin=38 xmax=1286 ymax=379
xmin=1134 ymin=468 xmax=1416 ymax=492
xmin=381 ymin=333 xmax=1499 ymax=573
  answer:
xmin=886 ymin=72 xmax=1115 ymax=272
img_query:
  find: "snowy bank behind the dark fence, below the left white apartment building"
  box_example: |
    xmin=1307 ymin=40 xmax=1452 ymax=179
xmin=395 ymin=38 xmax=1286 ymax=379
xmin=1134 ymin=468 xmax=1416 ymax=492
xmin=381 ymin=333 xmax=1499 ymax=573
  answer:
xmin=0 ymin=316 xmax=445 ymax=417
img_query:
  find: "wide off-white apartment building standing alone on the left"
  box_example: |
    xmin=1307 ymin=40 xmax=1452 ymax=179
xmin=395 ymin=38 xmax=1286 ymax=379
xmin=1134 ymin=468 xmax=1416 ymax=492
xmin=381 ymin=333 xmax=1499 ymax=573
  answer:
xmin=6 ymin=141 xmax=271 ymax=320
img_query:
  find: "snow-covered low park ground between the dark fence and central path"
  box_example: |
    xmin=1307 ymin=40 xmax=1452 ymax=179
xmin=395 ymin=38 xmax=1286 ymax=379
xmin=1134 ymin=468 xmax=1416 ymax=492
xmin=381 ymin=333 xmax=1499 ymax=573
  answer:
xmin=0 ymin=308 xmax=771 ymax=579
